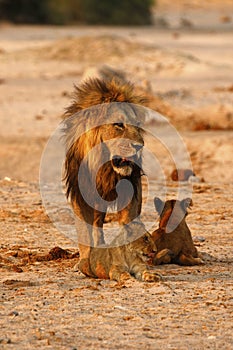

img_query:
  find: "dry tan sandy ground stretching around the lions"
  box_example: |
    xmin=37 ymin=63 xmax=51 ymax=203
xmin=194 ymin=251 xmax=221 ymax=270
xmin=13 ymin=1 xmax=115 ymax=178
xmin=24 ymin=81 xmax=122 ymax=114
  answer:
xmin=0 ymin=1 xmax=233 ymax=350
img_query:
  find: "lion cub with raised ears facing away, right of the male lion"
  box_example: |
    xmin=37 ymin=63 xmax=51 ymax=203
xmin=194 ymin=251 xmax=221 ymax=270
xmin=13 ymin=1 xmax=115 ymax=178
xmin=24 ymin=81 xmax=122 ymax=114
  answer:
xmin=152 ymin=198 xmax=203 ymax=266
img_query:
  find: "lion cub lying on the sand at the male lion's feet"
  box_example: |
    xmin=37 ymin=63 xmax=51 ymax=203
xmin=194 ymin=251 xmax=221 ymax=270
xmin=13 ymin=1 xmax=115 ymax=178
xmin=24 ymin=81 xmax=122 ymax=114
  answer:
xmin=79 ymin=222 xmax=160 ymax=282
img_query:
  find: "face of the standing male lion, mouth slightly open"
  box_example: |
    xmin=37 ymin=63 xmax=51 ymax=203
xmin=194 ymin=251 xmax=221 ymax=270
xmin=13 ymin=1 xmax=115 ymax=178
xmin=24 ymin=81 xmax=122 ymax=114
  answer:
xmin=102 ymin=122 xmax=144 ymax=176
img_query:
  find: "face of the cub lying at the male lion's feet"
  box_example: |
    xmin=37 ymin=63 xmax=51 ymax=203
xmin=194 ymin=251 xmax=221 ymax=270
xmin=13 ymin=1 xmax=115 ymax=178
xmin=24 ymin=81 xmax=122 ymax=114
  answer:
xmin=129 ymin=232 xmax=157 ymax=262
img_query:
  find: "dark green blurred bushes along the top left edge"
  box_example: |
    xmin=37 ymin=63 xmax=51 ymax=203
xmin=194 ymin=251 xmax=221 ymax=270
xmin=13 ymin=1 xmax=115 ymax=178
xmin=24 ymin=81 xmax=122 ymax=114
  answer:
xmin=0 ymin=0 xmax=154 ymax=25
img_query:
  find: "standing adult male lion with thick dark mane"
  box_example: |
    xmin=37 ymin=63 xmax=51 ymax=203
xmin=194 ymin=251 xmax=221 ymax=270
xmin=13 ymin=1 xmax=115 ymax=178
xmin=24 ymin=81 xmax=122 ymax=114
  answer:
xmin=64 ymin=78 xmax=145 ymax=276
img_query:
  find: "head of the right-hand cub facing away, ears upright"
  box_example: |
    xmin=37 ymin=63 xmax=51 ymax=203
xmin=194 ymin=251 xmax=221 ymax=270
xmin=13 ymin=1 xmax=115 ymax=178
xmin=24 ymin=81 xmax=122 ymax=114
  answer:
xmin=154 ymin=197 xmax=193 ymax=232
